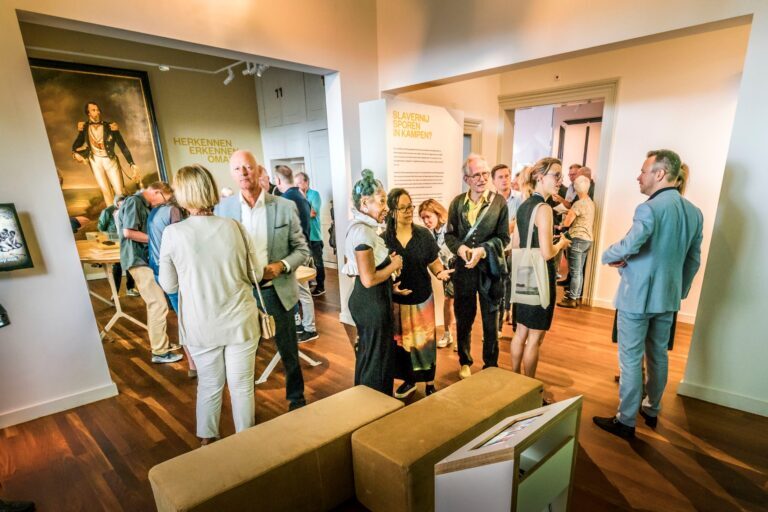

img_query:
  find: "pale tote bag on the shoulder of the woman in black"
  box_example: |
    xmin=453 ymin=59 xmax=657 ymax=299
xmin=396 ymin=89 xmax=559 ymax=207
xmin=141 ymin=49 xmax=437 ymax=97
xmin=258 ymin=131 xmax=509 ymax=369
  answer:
xmin=509 ymin=203 xmax=550 ymax=309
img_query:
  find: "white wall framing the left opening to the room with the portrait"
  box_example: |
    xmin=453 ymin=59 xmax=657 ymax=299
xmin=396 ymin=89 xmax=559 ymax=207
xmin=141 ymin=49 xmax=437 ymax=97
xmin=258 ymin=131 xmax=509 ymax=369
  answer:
xmin=0 ymin=0 xmax=378 ymax=425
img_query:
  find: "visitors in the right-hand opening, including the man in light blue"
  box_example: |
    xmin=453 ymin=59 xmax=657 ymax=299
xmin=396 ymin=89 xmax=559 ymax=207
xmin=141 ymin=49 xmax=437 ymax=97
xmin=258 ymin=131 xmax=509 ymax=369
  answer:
xmin=342 ymin=150 xmax=702 ymax=438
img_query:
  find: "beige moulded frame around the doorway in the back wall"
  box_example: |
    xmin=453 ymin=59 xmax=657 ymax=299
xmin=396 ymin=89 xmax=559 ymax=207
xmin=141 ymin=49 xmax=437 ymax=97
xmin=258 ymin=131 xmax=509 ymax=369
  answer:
xmin=497 ymin=78 xmax=619 ymax=306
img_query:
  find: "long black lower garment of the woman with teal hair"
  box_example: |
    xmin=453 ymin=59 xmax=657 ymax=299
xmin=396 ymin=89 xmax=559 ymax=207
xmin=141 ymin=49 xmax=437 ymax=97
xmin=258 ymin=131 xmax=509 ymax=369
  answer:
xmin=349 ymin=276 xmax=397 ymax=396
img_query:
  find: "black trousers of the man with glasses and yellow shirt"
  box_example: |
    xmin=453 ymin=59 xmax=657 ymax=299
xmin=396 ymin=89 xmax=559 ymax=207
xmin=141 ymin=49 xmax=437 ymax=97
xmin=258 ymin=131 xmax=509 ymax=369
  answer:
xmin=453 ymin=267 xmax=500 ymax=368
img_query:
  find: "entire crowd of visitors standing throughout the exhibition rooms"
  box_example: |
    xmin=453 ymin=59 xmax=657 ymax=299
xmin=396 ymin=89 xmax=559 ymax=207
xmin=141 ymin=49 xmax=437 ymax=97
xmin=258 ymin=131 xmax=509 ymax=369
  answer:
xmin=100 ymin=145 xmax=701 ymax=444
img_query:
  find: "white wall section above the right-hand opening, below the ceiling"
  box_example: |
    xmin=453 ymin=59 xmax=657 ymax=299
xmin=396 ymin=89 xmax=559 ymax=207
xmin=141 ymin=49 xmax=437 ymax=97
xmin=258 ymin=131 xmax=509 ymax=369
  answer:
xmin=376 ymin=0 xmax=764 ymax=91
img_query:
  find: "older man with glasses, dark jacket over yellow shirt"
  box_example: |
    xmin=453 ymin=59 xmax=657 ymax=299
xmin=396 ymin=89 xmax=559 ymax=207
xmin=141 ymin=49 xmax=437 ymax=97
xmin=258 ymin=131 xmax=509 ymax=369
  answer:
xmin=445 ymin=154 xmax=509 ymax=379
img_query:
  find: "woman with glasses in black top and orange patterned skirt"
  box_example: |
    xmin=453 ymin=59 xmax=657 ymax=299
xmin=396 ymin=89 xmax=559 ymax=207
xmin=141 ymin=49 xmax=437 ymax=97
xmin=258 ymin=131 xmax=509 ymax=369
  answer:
xmin=384 ymin=188 xmax=453 ymax=398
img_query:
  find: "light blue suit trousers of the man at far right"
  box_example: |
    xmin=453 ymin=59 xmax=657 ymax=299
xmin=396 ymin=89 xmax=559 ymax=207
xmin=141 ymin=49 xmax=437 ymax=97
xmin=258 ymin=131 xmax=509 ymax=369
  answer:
xmin=616 ymin=311 xmax=674 ymax=427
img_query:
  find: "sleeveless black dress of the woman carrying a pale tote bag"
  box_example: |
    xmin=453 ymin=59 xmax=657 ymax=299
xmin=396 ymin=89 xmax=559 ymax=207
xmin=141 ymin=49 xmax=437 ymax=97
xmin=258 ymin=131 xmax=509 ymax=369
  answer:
xmin=515 ymin=193 xmax=557 ymax=331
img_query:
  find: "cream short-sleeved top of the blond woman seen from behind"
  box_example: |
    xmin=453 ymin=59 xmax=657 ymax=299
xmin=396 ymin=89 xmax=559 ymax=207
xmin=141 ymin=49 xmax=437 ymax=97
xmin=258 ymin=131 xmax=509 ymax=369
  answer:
xmin=159 ymin=216 xmax=267 ymax=347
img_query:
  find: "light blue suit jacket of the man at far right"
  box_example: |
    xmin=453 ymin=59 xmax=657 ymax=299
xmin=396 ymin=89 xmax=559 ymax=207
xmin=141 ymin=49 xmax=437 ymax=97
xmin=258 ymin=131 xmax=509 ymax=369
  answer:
xmin=602 ymin=188 xmax=703 ymax=313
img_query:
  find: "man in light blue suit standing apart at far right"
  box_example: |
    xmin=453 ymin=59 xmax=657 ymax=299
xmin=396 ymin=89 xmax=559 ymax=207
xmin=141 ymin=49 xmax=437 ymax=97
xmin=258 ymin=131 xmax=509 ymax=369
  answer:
xmin=592 ymin=149 xmax=703 ymax=439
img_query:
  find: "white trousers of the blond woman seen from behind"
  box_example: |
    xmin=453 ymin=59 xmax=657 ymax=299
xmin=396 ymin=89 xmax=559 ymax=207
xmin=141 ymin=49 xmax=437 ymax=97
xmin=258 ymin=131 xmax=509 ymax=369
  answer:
xmin=187 ymin=341 xmax=258 ymax=438
